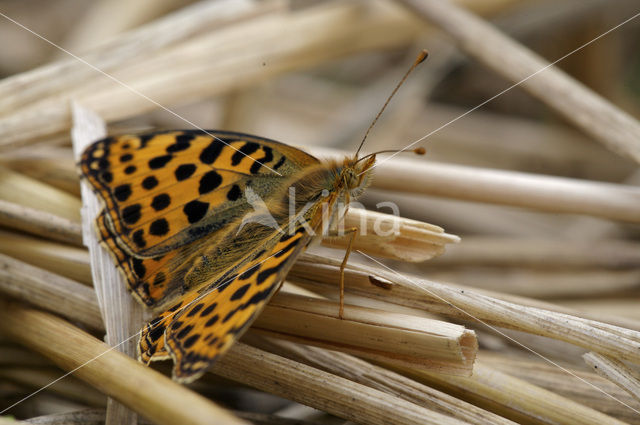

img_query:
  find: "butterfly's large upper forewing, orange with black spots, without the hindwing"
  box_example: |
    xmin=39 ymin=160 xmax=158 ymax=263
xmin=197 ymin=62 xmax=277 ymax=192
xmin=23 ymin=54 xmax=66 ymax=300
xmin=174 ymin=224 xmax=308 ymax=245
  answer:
xmin=80 ymin=130 xmax=318 ymax=258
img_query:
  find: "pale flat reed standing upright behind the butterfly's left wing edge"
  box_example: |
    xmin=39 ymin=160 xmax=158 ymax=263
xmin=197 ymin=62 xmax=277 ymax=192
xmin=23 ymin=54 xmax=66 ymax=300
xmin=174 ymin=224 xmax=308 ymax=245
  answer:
xmin=71 ymin=102 xmax=143 ymax=425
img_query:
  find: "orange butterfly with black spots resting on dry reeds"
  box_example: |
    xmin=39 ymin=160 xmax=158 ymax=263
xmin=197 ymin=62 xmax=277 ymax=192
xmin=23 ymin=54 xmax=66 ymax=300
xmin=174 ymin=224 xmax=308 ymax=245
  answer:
xmin=79 ymin=51 xmax=427 ymax=383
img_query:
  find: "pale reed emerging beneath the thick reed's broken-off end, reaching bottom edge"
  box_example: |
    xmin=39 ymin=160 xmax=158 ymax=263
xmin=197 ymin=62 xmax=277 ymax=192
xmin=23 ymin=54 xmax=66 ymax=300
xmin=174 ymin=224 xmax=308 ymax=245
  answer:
xmin=400 ymin=363 xmax=624 ymax=425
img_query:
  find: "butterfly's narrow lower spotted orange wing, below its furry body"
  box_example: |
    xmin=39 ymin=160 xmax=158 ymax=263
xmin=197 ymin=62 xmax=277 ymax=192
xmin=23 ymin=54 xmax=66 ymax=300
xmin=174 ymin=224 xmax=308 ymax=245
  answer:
xmin=139 ymin=226 xmax=311 ymax=382
